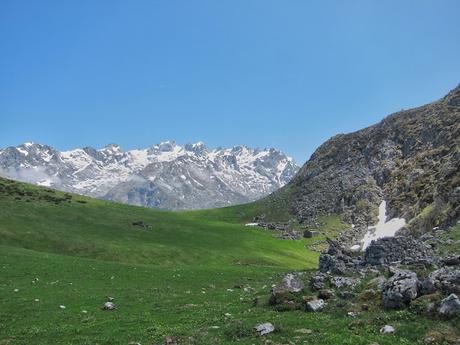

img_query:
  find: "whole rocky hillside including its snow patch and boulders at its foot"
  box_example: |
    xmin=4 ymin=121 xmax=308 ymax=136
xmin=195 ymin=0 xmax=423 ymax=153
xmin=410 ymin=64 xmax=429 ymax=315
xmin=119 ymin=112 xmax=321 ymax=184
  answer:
xmin=262 ymin=86 xmax=460 ymax=330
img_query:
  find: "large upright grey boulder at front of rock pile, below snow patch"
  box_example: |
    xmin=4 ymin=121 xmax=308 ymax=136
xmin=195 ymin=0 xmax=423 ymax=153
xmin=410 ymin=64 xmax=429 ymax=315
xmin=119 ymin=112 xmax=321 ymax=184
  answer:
xmin=383 ymin=270 xmax=418 ymax=309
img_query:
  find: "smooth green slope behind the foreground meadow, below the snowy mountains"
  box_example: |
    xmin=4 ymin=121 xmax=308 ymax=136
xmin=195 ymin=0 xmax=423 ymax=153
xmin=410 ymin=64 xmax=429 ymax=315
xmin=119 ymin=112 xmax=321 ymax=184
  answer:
xmin=0 ymin=180 xmax=316 ymax=268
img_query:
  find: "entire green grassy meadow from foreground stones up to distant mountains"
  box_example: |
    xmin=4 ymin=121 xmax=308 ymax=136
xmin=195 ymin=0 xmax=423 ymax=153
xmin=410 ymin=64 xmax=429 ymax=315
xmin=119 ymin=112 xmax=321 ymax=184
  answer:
xmin=0 ymin=179 xmax=456 ymax=345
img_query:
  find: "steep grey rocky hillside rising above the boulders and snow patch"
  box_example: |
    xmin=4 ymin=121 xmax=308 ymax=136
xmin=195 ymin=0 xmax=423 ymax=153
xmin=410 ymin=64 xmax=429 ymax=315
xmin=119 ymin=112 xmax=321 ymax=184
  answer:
xmin=284 ymin=86 xmax=460 ymax=232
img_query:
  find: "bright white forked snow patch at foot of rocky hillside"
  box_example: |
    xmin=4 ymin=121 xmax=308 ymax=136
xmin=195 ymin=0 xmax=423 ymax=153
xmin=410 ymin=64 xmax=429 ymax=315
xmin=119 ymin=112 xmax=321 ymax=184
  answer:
xmin=361 ymin=200 xmax=406 ymax=250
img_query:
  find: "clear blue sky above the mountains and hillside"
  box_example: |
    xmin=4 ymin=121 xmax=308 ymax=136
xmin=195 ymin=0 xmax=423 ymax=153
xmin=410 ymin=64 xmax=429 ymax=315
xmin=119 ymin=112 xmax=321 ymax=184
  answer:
xmin=0 ymin=0 xmax=460 ymax=163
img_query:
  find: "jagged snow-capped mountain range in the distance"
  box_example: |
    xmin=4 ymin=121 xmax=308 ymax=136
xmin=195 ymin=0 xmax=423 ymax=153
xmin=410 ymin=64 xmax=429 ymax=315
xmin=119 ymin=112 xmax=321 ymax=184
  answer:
xmin=0 ymin=141 xmax=299 ymax=210
